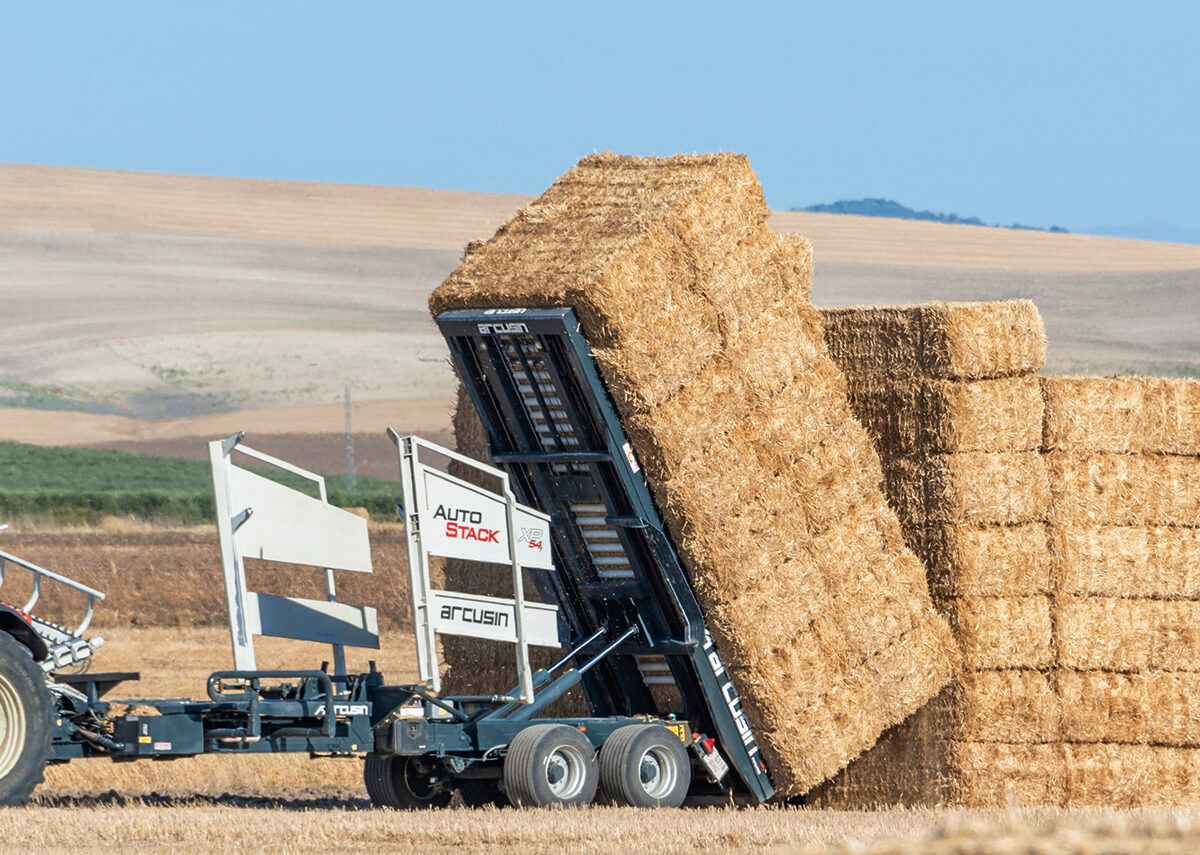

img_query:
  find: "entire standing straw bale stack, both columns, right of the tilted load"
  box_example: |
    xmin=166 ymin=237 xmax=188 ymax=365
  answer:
xmin=817 ymin=303 xmax=1200 ymax=807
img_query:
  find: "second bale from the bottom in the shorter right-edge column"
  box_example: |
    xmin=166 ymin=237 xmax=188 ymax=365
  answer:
xmin=1056 ymin=670 xmax=1200 ymax=747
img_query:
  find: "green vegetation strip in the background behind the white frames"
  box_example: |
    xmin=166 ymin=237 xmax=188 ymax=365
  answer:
xmin=0 ymin=442 xmax=401 ymax=524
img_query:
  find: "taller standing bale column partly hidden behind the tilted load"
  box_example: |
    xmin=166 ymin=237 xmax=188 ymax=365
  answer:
xmin=820 ymin=300 xmax=1063 ymax=807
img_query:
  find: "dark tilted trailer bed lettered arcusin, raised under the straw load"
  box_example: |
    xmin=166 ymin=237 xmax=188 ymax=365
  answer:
xmin=437 ymin=309 xmax=774 ymax=801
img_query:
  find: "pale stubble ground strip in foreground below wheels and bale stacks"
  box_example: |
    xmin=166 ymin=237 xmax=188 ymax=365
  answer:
xmin=7 ymin=797 xmax=1200 ymax=855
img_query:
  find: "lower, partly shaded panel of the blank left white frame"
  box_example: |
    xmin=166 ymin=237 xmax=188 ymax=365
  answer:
xmin=246 ymin=592 xmax=379 ymax=650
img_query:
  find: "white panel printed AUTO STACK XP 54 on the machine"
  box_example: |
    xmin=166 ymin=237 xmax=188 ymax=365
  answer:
xmin=419 ymin=466 xmax=554 ymax=570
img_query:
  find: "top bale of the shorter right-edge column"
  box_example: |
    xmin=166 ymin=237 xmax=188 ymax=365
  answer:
xmin=1042 ymin=377 xmax=1200 ymax=455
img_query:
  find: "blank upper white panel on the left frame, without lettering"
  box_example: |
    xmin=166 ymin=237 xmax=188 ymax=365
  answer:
xmin=229 ymin=466 xmax=371 ymax=573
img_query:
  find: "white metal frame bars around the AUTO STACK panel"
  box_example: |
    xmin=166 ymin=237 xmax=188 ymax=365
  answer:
xmin=388 ymin=428 xmax=559 ymax=704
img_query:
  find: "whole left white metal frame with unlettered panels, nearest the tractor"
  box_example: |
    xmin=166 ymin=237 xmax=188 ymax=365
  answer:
xmin=209 ymin=434 xmax=379 ymax=675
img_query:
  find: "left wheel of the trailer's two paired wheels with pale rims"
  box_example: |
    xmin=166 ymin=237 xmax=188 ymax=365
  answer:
xmin=504 ymin=724 xmax=600 ymax=807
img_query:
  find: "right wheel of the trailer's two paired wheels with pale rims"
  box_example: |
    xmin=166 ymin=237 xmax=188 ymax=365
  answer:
xmin=600 ymin=724 xmax=691 ymax=807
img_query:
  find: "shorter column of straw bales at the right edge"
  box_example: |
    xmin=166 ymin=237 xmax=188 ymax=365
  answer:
xmin=1043 ymin=377 xmax=1200 ymax=806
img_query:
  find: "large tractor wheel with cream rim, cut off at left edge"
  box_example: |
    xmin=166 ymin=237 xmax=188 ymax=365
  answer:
xmin=0 ymin=632 xmax=54 ymax=805
